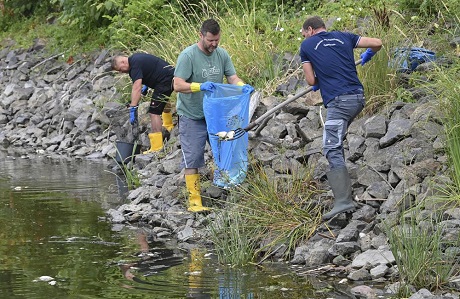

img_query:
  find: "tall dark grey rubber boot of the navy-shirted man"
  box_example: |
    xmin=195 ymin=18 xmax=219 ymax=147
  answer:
xmin=323 ymin=167 xmax=356 ymax=220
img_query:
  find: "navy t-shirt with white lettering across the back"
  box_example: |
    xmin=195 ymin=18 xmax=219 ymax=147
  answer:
xmin=300 ymin=31 xmax=363 ymax=106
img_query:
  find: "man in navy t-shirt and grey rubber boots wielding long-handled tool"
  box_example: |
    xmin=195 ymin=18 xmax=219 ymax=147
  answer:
xmin=300 ymin=16 xmax=382 ymax=220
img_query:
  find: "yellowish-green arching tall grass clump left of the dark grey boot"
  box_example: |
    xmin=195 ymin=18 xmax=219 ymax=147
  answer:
xmin=224 ymin=159 xmax=321 ymax=262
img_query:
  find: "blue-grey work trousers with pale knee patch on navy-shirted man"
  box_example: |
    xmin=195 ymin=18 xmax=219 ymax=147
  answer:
xmin=323 ymin=93 xmax=365 ymax=169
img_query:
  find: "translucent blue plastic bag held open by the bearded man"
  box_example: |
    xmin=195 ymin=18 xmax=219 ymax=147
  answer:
xmin=203 ymin=83 xmax=251 ymax=188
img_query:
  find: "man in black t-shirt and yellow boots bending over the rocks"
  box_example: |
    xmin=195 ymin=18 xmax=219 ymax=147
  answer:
xmin=112 ymin=53 xmax=174 ymax=154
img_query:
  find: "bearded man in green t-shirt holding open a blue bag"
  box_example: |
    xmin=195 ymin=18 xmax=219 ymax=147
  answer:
xmin=174 ymin=19 xmax=253 ymax=212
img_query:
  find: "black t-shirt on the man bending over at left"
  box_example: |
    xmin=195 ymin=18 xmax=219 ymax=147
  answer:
xmin=128 ymin=53 xmax=174 ymax=89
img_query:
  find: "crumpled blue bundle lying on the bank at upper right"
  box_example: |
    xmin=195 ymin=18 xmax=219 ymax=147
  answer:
xmin=390 ymin=47 xmax=436 ymax=73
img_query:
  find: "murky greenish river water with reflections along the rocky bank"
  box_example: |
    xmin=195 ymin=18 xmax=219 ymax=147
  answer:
xmin=0 ymin=151 xmax=356 ymax=299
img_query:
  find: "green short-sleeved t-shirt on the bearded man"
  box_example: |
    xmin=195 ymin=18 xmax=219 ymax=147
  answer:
xmin=174 ymin=44 xmax=236 ymax=119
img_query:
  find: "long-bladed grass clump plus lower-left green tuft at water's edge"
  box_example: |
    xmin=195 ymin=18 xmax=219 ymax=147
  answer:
xmin=210 ymin=158 xmax=321 ymax=264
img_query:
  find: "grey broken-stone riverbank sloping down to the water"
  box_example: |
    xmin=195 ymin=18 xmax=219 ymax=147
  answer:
xmin=0 ymin=40 xmax=460 ymax=298
